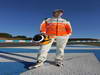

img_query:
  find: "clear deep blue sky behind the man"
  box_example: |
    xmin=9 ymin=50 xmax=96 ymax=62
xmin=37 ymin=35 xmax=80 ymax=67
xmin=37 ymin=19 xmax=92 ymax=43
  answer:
xmin=0 ymin=0 xmax=100 ymax=38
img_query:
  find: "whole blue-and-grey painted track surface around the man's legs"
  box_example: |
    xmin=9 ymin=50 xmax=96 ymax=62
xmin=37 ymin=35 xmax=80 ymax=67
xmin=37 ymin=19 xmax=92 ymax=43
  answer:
xmin=0 ymin=46 xmax=100 ymax=75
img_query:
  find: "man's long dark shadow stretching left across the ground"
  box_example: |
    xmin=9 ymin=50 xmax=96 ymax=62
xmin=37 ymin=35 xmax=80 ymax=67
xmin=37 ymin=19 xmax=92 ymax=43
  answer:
xmin=0 ymin=51 xmax=55 ymax=70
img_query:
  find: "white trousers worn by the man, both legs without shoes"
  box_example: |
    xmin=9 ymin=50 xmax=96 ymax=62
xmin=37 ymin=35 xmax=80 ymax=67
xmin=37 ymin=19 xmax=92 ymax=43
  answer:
xmin=37 ymin=35 xmax=69 ymax=62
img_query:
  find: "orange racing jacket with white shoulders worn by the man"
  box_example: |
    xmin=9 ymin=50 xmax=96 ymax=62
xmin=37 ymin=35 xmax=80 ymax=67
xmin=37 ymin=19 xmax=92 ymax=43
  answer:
xmin=40 ymin=17 xmax=72 ymax=38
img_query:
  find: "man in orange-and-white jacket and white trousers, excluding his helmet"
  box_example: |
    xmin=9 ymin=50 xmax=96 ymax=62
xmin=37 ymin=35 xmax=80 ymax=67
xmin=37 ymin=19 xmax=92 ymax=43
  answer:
xmin=29 ymin=9 xmax=72 ymax=69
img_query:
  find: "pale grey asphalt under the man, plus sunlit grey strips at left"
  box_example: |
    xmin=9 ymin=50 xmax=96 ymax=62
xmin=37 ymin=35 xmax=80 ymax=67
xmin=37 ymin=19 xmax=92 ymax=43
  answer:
xmin=0 ymin=53 xmax=100 ymax=75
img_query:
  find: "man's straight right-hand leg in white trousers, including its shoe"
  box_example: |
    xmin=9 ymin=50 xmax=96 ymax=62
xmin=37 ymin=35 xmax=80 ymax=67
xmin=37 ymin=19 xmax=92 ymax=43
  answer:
xmin=55 ymin=36 xmax=69 ymax=66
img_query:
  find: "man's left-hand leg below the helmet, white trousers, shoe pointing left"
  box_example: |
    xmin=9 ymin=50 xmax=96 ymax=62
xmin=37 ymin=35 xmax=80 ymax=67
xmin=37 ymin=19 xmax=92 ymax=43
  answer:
xmin=29 ymin=38 xmax=54 ymax=69
